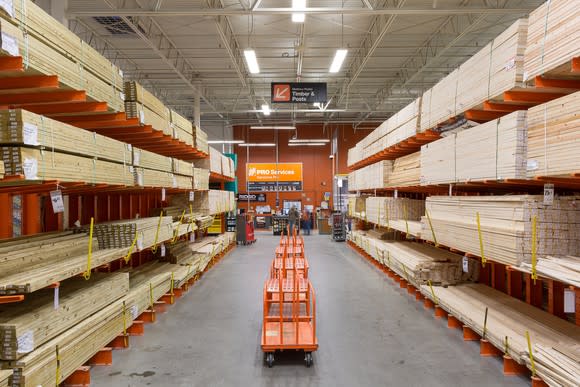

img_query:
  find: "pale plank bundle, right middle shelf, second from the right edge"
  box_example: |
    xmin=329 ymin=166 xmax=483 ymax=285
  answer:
xmin=421 ymin=111 xmax=527 ymax=185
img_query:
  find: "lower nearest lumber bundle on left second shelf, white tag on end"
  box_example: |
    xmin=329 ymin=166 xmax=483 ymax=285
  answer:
xmin=0 ymin=147 xmax=133 ymax=186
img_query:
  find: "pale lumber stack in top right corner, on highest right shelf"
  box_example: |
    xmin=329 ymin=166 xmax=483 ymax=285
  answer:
xmin=524 ymin=0 xmax=580 ymax=80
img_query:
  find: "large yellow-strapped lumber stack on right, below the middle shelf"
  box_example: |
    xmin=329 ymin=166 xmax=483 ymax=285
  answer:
xmin=421 ymin=195 xmax=580 ymax=266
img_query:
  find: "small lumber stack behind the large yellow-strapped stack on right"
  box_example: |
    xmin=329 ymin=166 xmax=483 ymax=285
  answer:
xmin=365 ymin=197 xmax=425 ymax=236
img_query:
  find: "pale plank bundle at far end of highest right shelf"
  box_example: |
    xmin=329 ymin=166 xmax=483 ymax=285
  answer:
xmin=347 ymin=98 xmax=421 ymax=166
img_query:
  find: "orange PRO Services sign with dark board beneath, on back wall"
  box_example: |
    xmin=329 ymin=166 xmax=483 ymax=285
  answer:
xmin=246 ymin=163 xmax=302 ymax=192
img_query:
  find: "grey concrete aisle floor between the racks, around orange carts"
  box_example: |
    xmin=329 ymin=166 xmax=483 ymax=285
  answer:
xmin=92 ymin=233 xmax=529 ymax=387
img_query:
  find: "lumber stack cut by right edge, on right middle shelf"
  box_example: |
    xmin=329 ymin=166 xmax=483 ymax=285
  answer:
xmin=528 ymin=92 xmax=580 ymax=177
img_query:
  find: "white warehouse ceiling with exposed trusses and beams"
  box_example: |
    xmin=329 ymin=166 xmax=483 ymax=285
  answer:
xmin=60 ymin=0 xmax=543 ymax=132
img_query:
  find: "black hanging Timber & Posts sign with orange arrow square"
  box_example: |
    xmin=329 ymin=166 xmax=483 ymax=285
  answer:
xmin=270 ymin=82 xmax=326 ymax=103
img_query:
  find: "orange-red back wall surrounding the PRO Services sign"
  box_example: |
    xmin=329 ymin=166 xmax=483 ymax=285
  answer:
xmin=234 ymin=124 xmax=370 ymax=209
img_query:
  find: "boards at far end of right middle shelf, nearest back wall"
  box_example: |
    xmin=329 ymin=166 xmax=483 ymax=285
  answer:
xmin=348 ymin=152 xmax=421 ymax=191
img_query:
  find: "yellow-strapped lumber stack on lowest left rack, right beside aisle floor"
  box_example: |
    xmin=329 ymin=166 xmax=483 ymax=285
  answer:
xmin=9 ymin=264 xmax=171 ymax=387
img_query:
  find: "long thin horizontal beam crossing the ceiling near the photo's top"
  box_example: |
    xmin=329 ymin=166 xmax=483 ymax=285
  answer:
xmin=67 ymin=7 xmax=530 ymax=17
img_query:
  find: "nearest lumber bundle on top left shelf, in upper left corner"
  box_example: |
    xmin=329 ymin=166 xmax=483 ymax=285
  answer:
xmin=0 ymin=0 xmax=123 ymax=111
